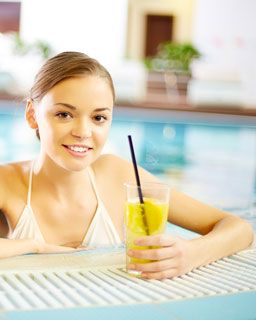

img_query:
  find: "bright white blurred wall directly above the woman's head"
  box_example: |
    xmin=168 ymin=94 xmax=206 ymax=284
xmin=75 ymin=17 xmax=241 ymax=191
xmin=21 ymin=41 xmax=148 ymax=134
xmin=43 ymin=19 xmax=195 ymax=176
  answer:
xmin=20 ymin=0 xmax=128 ymax=63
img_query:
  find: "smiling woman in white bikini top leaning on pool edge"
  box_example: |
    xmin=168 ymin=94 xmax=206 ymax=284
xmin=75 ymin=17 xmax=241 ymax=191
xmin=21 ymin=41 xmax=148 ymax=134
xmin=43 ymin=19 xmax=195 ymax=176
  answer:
xmin=0 ymin=52 xmax=253 ymax=279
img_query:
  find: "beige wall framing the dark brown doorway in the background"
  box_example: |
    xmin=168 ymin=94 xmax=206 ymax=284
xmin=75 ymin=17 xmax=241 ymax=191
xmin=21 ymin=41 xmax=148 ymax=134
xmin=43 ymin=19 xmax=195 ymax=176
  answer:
xmin=126 ymin=0 xmax=196 ymax=59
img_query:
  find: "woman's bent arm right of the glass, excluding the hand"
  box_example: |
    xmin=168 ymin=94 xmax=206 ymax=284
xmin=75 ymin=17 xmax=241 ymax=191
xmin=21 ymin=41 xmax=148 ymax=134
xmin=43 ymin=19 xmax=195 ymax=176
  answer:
xmin=169 ymin=191 xmax=253 ymax=265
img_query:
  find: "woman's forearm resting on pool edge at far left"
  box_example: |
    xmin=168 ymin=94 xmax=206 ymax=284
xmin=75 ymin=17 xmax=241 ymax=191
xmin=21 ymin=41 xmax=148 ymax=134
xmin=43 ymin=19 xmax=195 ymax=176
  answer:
xmin=0 ymin=238 xmax=38 ymax=259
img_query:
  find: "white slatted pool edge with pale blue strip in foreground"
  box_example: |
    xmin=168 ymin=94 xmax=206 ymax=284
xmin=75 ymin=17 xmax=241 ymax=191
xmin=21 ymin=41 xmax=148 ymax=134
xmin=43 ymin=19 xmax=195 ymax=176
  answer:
xmin=0 ymin=248 xmax=256 ymax=320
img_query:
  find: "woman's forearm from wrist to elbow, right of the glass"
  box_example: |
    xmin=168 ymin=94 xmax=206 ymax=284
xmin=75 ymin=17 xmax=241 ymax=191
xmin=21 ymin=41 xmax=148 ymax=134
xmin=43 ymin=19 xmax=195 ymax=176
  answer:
xmin=191 ymin=216 xmax=253 ymax=267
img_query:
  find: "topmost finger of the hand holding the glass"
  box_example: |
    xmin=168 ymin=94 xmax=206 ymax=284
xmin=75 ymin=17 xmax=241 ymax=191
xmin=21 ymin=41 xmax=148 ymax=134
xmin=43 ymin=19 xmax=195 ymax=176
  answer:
xmin=134 ymin=234 xmax=177 ymax=247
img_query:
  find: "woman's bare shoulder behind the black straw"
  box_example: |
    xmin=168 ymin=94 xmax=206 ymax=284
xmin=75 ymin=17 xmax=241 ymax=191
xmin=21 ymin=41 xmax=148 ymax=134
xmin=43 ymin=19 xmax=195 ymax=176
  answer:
xmin=92 ymin=154 xmax=158 ymax=182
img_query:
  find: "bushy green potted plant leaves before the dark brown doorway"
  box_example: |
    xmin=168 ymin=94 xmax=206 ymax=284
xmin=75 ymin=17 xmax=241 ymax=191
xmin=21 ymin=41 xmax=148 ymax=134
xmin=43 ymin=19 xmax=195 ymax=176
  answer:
xmin=145 ymin=41 xmax=201 ymax=73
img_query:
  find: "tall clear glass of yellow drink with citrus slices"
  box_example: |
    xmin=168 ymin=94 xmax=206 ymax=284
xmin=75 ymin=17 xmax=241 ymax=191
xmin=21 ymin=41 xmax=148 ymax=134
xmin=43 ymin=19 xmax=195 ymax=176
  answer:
xmin=125 ymin=182 xmax=170 ymax=275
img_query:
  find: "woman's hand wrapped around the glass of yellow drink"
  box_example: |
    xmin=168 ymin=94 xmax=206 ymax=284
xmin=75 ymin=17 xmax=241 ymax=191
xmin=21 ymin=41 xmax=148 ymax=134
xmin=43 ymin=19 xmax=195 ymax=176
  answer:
xmin=128 ymin=235 xmax=194 ymax=279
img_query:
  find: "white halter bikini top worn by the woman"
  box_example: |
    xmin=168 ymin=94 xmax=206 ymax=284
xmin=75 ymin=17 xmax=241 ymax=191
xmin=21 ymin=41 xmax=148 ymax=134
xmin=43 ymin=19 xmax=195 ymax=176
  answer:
xmin=8 ymin=165 xmax=122 ymax=247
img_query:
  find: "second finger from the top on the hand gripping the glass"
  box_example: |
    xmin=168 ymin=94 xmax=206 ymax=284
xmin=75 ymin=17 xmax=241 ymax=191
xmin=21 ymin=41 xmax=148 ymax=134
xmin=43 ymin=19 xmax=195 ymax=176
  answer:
xmin=128 ymin=247 xmax=176 ymax=260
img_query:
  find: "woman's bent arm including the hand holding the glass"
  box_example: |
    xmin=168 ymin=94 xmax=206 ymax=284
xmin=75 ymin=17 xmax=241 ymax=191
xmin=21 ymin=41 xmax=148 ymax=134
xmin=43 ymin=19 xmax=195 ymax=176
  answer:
xmin=127 ymin=164 xmax=253 ymax=279
